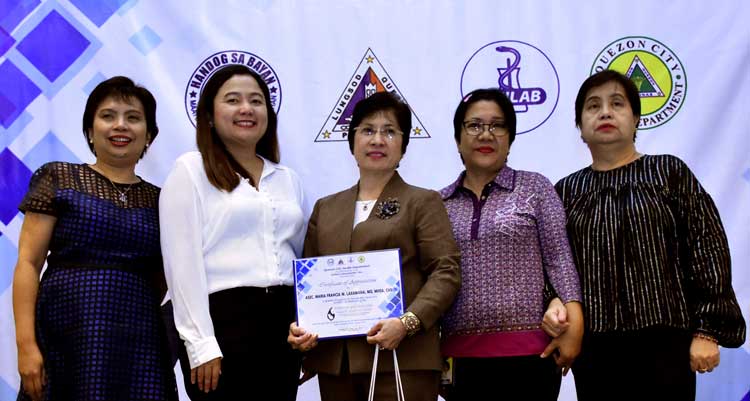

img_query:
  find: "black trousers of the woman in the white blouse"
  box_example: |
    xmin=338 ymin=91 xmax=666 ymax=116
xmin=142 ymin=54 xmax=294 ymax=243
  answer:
xmin=178 ymin=286 xmax=301 ymax=401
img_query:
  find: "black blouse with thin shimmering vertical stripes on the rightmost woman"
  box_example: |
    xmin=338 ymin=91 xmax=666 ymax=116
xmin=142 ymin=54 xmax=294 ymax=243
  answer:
xmin=556 ymin=155 xmax=745 ymax=347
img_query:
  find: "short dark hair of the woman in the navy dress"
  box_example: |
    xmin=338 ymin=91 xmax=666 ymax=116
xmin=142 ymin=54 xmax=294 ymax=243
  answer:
xmin=83 ymin=76 xmax=159 ymax=158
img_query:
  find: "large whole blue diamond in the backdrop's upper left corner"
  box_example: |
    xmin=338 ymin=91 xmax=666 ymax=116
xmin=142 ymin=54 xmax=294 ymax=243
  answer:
xmin=17 ymin=10 xmax=91 ymax=82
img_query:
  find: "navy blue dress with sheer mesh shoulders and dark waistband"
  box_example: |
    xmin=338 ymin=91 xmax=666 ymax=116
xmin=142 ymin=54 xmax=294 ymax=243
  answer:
xmin=19 ymin=162 xmax=177 ymax=401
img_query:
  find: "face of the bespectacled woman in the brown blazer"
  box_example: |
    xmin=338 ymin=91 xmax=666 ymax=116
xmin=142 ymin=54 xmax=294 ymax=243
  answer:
xmin=354 ymin=110 xmax=403 ymax=175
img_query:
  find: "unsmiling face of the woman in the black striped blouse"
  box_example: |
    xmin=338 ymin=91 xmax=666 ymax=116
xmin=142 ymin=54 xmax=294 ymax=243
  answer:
xmin=581 ymin=81 xmax=638 ymax=147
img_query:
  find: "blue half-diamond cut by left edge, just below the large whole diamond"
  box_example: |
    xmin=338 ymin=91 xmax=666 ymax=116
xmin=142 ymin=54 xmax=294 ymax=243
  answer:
xmin=0 ymin=60 xmax=42 ymax=128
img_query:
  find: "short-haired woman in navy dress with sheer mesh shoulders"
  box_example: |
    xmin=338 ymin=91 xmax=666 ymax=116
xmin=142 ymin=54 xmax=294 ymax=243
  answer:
xmin=13 ymin=77 xmax=177 ymax=400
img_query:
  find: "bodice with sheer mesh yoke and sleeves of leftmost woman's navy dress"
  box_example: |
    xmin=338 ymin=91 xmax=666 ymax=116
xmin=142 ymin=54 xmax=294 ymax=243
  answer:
xmin=19 ymin=162 xmax=162 ymax=274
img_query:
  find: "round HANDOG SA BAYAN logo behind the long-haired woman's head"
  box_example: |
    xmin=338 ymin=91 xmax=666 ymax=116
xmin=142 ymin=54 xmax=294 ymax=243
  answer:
xmin=185 ymin=50 xmax=281 ymax=126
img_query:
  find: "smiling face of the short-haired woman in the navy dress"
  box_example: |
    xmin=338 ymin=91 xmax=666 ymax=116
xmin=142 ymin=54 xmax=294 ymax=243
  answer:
xmin=88 ymin=96 xmax=150 ymax=166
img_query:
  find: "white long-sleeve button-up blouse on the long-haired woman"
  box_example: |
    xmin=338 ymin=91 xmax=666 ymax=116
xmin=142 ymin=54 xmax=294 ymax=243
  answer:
xmin=159 ymin=152 xmax=305 ymax=369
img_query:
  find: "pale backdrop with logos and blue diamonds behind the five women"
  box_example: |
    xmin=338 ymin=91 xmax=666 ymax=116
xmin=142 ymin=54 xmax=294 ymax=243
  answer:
xmin=0 ymin=0 xmax=750 ymax=401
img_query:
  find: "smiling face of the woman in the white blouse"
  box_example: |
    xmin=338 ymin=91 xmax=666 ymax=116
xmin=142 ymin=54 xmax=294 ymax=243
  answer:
xmin=211 ymin=75 xmax=268 ymax=149
